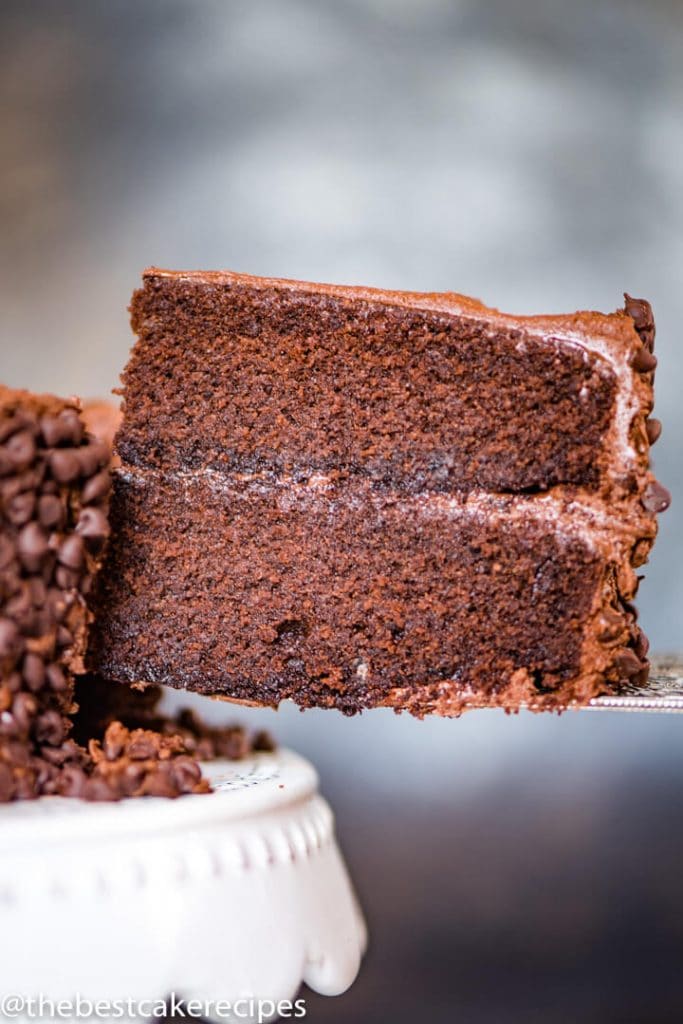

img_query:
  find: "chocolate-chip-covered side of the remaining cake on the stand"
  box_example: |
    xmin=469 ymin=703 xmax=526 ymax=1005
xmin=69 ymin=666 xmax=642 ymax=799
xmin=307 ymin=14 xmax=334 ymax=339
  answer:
xmin=0 ymin=394 xmax=110 ymax=801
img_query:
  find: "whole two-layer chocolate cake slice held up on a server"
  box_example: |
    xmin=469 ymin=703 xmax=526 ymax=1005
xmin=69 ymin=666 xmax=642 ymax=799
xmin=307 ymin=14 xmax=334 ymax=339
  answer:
xmin=90 ymin=269 xmax=669 ymax=715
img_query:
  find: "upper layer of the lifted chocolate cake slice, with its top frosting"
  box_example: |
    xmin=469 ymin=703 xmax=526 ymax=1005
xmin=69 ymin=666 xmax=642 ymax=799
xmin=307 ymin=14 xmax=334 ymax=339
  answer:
xmin=118 ymin=268 xmax=655 ymax=498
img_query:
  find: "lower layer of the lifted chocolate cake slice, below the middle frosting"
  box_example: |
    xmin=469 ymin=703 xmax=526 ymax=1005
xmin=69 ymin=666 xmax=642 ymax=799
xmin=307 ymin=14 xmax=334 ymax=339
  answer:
xmin=89 ymin=469 xmax=651 ymax=714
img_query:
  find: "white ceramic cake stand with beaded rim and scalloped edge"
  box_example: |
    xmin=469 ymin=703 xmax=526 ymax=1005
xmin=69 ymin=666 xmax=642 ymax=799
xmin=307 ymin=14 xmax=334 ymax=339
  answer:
xmin=0 ymin=751 xmax=366 ymax=1021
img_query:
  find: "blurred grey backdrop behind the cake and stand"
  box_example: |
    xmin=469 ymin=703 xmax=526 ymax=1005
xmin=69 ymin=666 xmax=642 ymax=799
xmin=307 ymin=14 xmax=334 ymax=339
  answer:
xmin=0 ymin=0 xmax=683 ymax=1024
